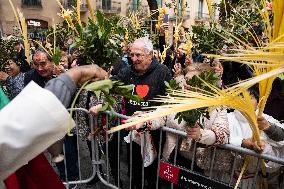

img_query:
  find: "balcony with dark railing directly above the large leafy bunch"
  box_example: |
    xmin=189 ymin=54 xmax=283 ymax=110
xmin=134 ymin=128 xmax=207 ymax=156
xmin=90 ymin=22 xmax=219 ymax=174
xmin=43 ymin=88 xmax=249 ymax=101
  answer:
xmin=97 ymin=0 xmax=121 ymax=14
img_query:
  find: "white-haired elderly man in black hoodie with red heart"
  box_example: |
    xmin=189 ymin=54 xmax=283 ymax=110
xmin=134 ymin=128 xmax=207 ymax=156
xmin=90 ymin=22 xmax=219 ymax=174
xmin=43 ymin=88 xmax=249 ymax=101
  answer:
xmin=112 ymin=37 xmax=171 ymax=188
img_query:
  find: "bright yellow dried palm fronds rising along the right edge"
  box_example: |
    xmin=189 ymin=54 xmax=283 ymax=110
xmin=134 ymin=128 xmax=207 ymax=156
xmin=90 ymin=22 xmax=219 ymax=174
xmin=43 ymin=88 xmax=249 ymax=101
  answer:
xmin=213 ymin=0 xmax=284 ymax=116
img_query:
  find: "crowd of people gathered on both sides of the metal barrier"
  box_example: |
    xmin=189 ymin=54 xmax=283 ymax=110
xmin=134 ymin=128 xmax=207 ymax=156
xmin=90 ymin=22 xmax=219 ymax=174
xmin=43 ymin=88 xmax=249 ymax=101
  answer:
xmin=0 ymin=23 xmax=284 ymax=189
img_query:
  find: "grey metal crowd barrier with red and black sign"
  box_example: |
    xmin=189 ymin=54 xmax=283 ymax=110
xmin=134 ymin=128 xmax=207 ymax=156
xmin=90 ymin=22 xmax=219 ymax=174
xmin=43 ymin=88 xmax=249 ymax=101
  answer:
xmin=52 ymin=108 xmax=284 ymax=189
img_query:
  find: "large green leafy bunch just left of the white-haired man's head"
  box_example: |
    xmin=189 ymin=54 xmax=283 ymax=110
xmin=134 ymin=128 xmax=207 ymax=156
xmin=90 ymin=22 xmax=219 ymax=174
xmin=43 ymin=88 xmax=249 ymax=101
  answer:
xmin=72 ymin=10 xmax=125 ymax=69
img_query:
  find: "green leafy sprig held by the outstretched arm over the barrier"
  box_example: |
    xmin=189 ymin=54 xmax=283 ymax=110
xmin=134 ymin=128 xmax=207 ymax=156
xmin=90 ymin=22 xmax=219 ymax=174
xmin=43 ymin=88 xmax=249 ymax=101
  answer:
xmin=85 ymin=79 xmax=141 ymax=111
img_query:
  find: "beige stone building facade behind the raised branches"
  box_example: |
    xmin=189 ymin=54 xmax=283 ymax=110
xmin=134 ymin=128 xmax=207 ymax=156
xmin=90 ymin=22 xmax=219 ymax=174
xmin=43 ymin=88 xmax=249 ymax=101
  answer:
xmin=0 ymin=0 xmax=220 ymax=37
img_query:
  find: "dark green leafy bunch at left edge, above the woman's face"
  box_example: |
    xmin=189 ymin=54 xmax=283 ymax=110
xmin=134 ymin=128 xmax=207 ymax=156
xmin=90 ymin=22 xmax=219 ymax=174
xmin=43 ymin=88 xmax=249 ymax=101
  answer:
xmin=0 ymin=38 xmax=18 ymax=70
